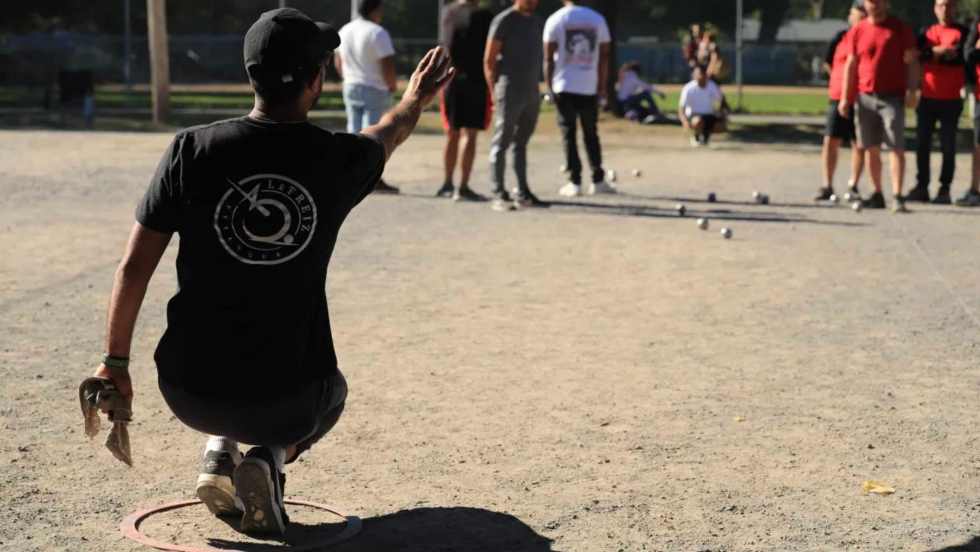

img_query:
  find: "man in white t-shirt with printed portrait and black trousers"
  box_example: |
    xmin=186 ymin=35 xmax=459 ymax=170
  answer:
xmin=544 ymin=0 xmax=616 ymax=197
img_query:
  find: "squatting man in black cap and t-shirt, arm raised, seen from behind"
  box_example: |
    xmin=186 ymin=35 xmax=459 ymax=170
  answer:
xmin=86 ymin=8 xmax=453 ymax=534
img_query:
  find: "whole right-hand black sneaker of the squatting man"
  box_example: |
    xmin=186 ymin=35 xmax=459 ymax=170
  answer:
xmin=235 ymin=447 xmax=289 ymax=535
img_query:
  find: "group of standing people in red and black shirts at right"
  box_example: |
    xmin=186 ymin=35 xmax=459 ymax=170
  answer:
xmin=816 ymin=0 xmax=980 ymax=212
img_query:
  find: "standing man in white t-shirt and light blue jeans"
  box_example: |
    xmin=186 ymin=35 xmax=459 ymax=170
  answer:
xmin=333 ymin=0 xmax=398 ymax=194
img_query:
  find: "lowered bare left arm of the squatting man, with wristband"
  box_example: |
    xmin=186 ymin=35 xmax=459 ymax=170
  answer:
xmin=95 ymin=222 xmax=172 ymax=400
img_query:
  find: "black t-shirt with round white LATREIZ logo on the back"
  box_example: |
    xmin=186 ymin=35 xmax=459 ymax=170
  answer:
xmin=136 ymin=117 xmax=385 ymax=398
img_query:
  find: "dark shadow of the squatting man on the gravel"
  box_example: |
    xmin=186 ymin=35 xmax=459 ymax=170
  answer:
xmin=208 ymin=508 xmax=552 ymax=552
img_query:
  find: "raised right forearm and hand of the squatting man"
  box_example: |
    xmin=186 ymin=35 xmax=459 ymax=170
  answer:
xmin=361 ymin=46 xmax=456 ymax=158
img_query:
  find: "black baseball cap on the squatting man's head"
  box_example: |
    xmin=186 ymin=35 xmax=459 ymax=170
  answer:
xmin=245 ymin=8 xmax=340 ymax=87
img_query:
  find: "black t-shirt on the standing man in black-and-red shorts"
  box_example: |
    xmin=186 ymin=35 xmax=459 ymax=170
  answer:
xmin=442 ymin=4 xmax=493 ymax=82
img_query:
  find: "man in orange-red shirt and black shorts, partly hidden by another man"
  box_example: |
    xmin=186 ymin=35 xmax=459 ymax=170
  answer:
xmin=814 ymin=0 xmax=868 ymax=201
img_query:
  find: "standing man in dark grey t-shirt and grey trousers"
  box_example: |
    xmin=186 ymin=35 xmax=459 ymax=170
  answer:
xmin=483 ymin=0 xmax=547 ymax=210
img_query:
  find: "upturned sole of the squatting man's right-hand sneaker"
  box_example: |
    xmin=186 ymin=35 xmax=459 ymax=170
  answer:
xmin=235 ymin=458 xmax=286 ymax=535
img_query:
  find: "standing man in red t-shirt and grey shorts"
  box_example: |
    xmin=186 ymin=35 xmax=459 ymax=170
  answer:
xmin=839 ymin=0 xmax=919 ymax=213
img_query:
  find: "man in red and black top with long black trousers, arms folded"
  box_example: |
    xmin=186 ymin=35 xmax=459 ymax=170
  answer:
xmin=905 ymin=0 xmax=967 ymax=205
